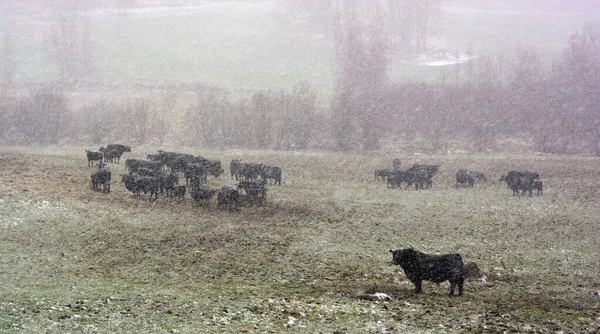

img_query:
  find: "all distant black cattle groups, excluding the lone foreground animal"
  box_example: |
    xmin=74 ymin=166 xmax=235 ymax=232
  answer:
xmin=86 ymin=144 xmax=543 ymax=209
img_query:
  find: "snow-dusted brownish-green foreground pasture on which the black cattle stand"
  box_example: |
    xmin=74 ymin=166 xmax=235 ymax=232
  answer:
xmin=0 ymin=147 xmax=600 ymax=333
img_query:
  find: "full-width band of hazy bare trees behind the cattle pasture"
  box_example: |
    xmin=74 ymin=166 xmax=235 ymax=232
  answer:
xmin=0 ymin=0 xmax=600 ymax=155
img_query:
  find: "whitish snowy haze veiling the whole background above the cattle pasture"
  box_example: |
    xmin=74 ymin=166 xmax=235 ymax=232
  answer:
xmin=0 ymin=0 xmax=600 ymax=155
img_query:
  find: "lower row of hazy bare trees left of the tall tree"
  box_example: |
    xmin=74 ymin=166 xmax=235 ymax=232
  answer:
xmin=0 ymin=84 xmax=332 ymax=150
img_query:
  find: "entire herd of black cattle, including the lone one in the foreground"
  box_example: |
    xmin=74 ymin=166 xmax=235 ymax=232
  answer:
xmin=86 ymin=149 xmax=556 ymax=295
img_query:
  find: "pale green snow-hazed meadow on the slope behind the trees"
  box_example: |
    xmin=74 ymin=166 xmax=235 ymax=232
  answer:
xmin=0 ymin=2 xmax=600 ymax=93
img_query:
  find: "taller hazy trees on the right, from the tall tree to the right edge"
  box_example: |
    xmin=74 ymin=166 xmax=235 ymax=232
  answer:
xmin=332 ymin=26 xmax=600 ymax=155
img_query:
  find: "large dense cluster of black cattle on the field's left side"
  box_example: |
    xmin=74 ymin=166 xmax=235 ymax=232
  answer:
xmin=86 ymin=144 xmax=281 ymax=210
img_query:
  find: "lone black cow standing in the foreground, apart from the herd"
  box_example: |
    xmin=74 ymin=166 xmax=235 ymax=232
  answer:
xmin=390 ymin=248 xmax=466 ymax=295
